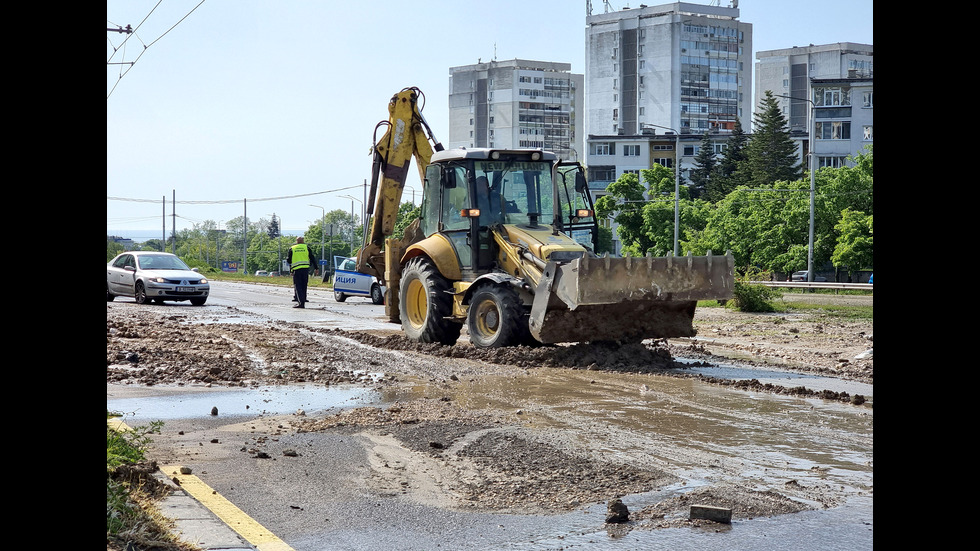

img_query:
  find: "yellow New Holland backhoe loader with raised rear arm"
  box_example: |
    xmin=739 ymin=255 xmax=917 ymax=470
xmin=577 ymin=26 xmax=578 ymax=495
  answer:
xmin=357 ymin=88 xmax=734 ymax=347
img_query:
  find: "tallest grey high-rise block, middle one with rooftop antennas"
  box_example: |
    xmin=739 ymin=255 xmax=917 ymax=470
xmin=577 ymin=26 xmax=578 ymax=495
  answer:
xmin=585 ymin=2 xmax=752 ymax=135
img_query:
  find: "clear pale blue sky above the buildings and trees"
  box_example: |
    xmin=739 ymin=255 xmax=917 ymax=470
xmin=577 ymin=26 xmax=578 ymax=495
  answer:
xmin=106 ymin=0 xmax=874 ymax=238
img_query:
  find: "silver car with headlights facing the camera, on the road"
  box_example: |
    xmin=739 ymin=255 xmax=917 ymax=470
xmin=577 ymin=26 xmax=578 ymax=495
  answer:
xmin=105 ymin=251 xmax=211 ymax=306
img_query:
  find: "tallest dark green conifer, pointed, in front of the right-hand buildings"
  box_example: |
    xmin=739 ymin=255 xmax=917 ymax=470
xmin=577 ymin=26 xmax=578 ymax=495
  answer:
xmin=739 ymin=90 xmax=801 ymax=187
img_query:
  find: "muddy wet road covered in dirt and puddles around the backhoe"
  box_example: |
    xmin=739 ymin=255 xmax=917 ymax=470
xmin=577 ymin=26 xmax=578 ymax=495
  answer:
xmin=106 ymin=284 xmax=873 ymax=549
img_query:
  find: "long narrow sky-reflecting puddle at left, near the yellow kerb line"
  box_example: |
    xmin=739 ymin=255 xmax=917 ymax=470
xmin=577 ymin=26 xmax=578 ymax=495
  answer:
xmin=106 ymin=385 xmax=380 ymax=423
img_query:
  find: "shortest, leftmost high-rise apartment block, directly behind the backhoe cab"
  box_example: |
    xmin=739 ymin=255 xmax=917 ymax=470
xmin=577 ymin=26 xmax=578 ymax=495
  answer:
xmin=448 ymin=59 xmax=584 ymax=161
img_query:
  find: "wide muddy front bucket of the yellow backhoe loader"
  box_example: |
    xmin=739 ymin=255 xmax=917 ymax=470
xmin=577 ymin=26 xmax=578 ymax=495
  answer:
xmin=530 ymin=252 xmax=735 ymax=343
